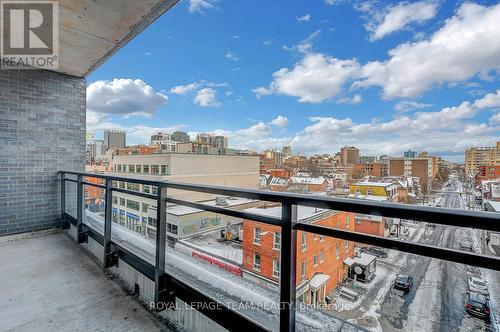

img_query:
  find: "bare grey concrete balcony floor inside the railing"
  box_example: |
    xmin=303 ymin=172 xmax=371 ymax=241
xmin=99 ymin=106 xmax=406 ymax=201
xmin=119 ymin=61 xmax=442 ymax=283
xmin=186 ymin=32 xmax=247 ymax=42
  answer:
xmin=0 ymin=233 xmax=169 ymax=331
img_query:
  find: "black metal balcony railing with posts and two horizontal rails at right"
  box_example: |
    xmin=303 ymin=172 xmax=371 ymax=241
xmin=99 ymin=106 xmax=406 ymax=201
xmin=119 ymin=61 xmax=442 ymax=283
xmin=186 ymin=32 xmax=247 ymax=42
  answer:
xmin=61 ymin=171 xmax=500 ymax=331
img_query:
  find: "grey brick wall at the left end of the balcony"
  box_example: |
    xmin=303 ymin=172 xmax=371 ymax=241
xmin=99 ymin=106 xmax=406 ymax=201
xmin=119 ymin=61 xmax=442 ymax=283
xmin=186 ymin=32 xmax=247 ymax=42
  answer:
xmin=0 ymin=70 xmax=86 ymax=235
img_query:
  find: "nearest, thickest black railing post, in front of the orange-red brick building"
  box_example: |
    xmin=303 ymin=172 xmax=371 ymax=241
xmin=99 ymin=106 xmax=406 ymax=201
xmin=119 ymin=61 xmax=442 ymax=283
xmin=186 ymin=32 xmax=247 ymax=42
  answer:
xmin=280 ymin=203 xmax=297 ymax=332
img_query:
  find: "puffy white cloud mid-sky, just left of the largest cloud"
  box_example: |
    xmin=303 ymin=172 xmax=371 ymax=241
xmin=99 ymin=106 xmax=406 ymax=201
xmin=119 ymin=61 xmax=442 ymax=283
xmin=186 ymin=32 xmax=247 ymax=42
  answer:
xmin=253 ymin=53 xmax=360 ymax=103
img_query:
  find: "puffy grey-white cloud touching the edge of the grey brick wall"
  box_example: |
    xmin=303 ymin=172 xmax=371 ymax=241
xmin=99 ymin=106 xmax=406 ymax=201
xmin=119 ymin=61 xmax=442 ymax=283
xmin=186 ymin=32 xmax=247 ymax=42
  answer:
xmin=87 ymin=78 xmax=168 ymax=117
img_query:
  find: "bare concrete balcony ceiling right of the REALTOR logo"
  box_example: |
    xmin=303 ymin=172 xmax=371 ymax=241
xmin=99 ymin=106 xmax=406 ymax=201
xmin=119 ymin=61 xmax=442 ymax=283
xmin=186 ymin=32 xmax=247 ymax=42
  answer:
xmin=58 ymin=0 xmax=178 ymax=77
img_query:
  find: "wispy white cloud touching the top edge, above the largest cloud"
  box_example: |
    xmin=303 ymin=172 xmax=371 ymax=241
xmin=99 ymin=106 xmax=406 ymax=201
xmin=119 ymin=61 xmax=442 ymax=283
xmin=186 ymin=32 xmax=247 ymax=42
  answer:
xmin=362 ymin=1 xmax=439 ymax=41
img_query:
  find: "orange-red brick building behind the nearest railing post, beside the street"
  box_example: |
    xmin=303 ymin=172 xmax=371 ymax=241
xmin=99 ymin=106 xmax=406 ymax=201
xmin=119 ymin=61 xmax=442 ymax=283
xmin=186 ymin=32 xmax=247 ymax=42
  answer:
xmin=243 ymin=206 xmax=354 ymax=303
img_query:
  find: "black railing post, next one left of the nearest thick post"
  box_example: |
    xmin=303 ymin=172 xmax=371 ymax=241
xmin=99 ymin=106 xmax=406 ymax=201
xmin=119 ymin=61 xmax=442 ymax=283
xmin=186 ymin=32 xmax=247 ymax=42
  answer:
xmin=155 ymin=186 xmax=167 ymax=303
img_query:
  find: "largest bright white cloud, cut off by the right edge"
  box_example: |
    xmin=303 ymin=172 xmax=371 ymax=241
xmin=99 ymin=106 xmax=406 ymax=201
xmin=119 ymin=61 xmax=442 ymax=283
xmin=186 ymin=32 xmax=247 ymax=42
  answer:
xmin=354 ymin=3 xmax=500 ymax=98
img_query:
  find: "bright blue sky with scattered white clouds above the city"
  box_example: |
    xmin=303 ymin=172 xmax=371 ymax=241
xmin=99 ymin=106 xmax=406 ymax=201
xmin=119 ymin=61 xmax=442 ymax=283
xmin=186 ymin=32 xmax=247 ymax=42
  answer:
xmin=87 ymin=0 xmax=500 ymax=161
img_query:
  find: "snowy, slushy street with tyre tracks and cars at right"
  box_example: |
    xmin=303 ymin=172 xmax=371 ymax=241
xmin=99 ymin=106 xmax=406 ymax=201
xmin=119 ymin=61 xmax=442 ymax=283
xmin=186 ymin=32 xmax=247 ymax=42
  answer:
xmin=335 ymin=178 xmax=500 ymax=331
